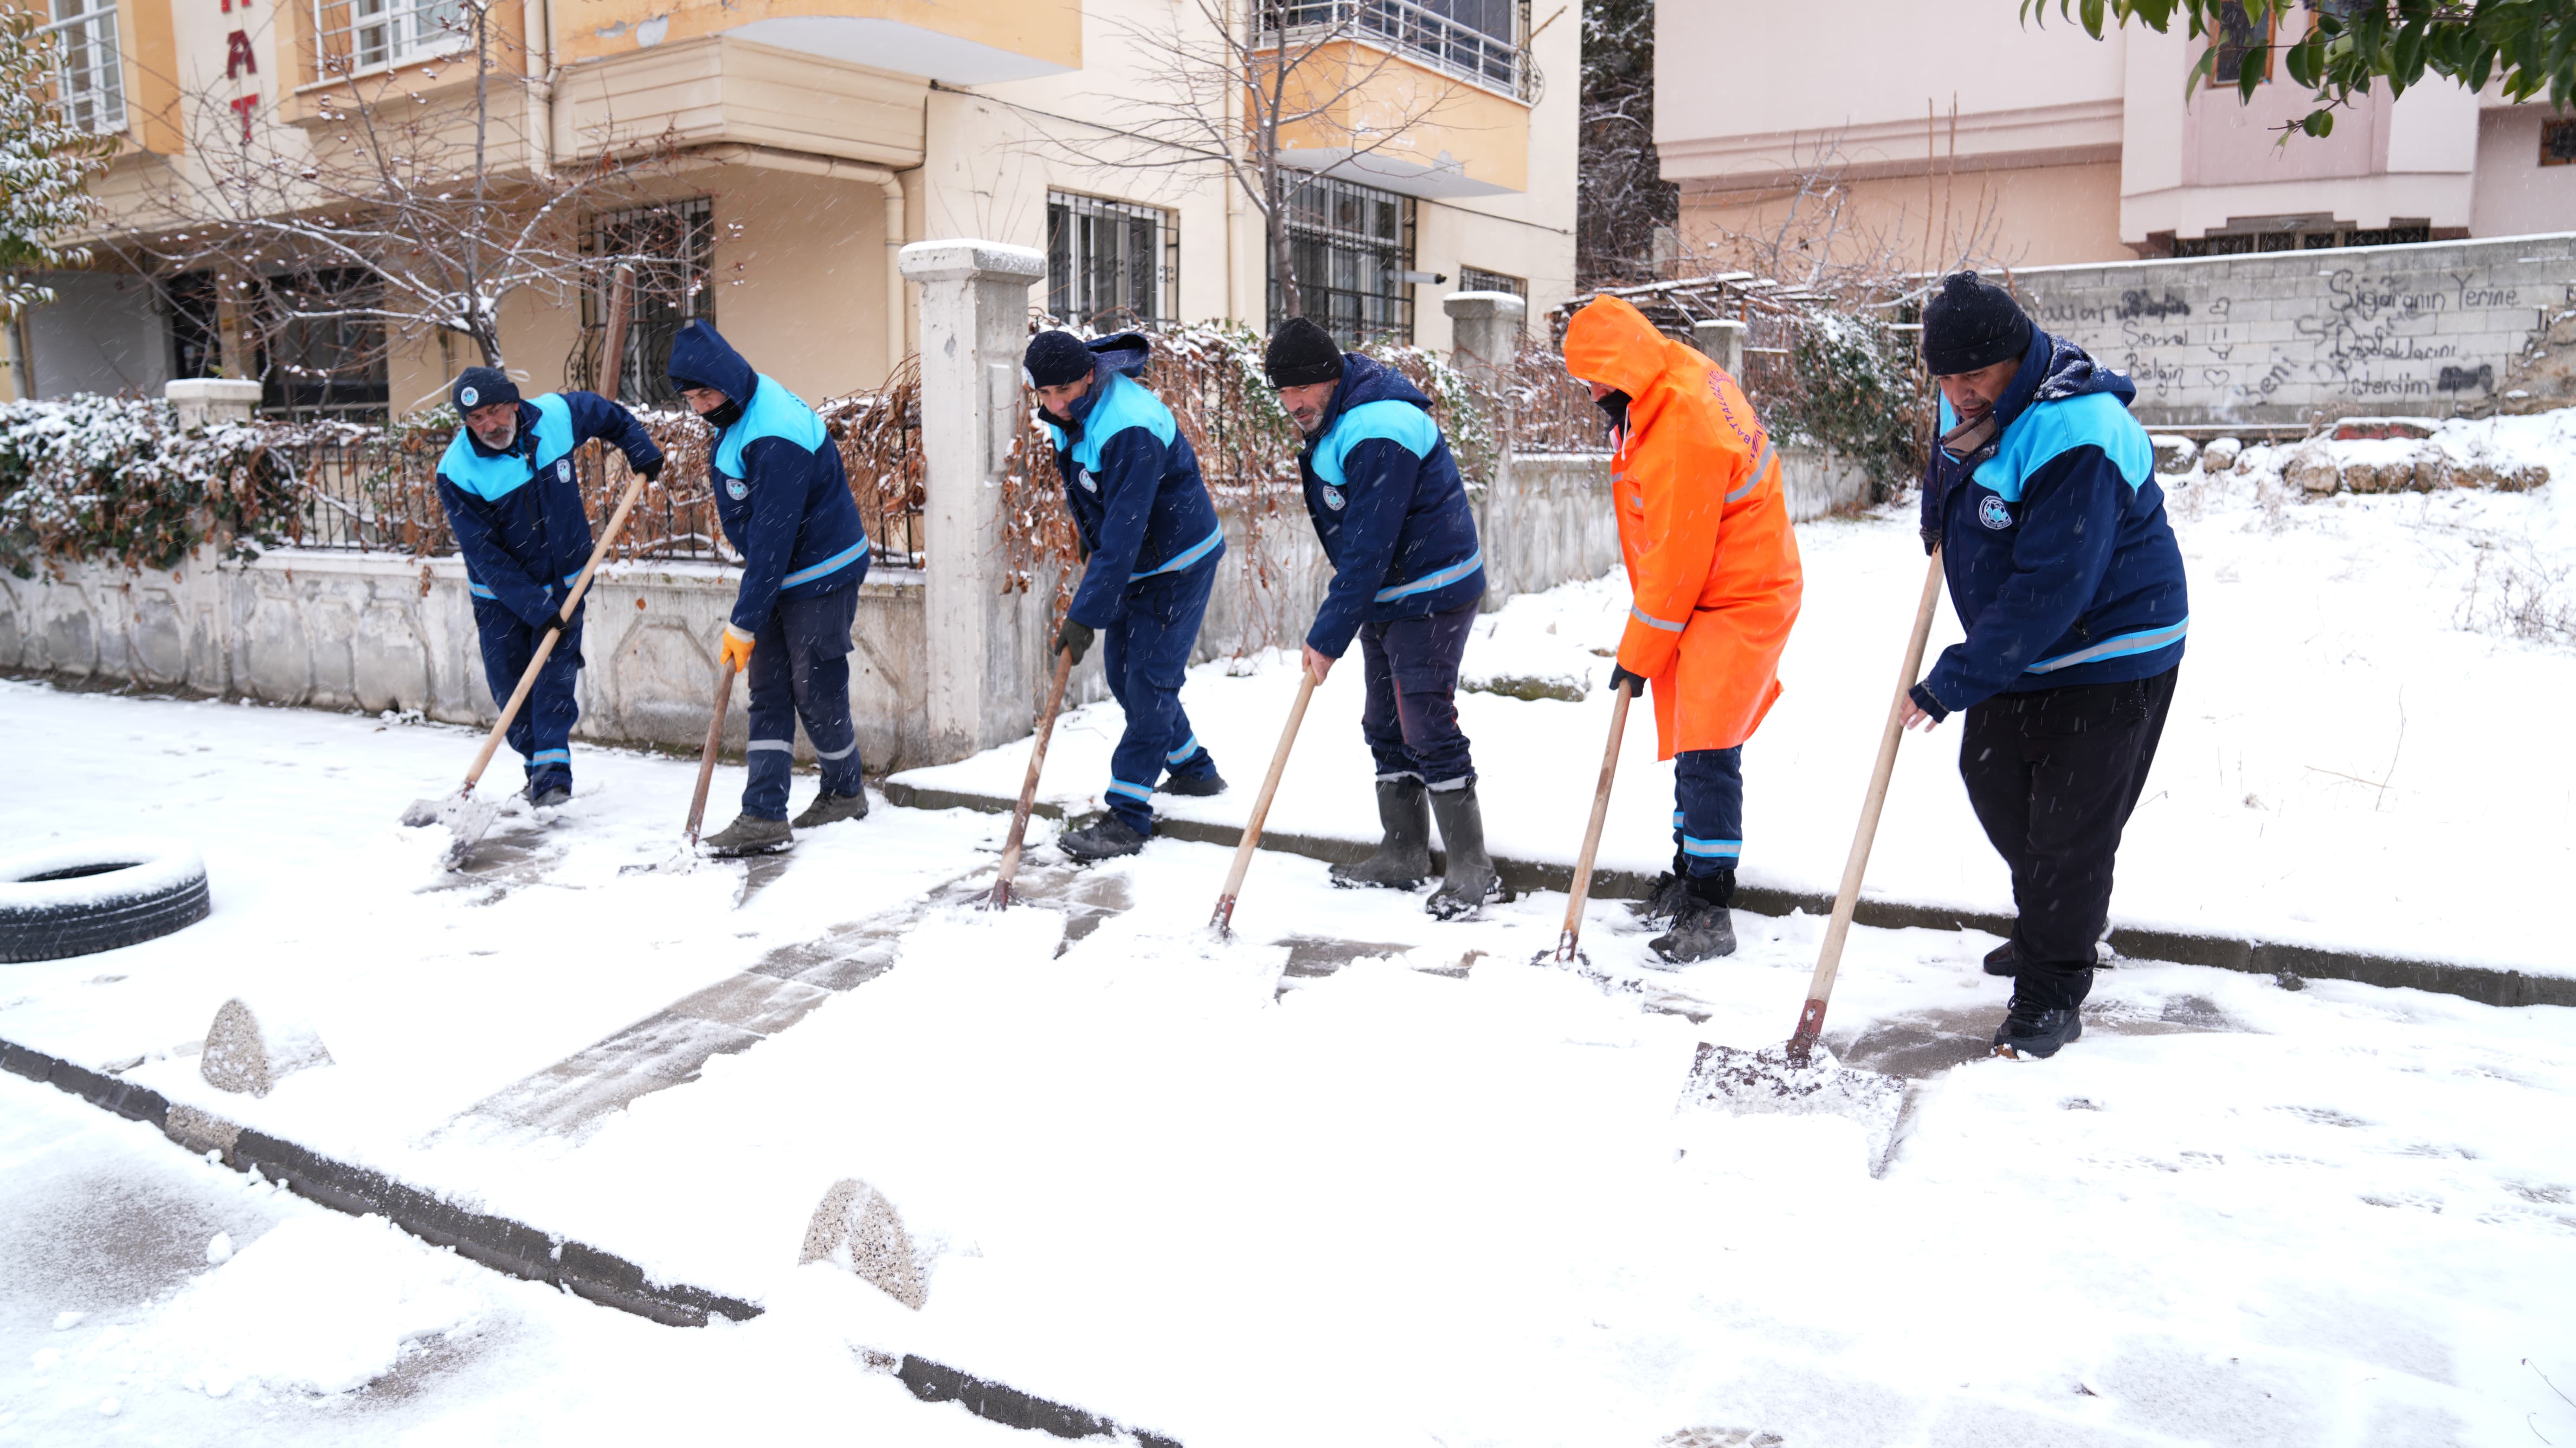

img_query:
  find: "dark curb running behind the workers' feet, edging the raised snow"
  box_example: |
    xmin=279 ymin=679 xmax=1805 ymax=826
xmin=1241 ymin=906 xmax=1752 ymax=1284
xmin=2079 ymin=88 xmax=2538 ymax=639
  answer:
xmin=884 ymin=778 xmax=2576 ymax=1005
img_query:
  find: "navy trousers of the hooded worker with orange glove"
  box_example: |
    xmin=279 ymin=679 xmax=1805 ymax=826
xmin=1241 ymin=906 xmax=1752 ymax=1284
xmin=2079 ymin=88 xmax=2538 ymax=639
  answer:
xmin=742 ymin=577 xmax=868 ymax=819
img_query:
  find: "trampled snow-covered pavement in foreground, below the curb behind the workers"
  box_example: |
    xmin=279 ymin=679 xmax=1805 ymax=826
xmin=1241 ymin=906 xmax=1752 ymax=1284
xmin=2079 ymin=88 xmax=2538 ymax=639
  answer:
xmin=0 ymin=675 xmax=2576 ymax=1448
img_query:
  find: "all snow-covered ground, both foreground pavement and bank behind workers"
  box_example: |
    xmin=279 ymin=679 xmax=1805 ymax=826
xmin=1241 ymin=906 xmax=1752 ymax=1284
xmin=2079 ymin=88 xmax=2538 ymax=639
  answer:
xmin=0 ymin=443 xmax=2576 ymax=1448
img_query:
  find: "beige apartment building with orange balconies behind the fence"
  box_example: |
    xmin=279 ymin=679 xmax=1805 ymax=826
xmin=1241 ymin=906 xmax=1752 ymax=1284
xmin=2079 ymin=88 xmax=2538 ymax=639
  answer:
xmin=13 ymin=0 xmax=1582 ymax=415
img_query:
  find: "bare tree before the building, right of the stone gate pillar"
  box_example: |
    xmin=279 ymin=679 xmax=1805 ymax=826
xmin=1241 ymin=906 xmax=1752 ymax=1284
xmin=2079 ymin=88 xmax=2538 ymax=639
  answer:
xmin=1025 ymin=0 xmax=1463 ymax=317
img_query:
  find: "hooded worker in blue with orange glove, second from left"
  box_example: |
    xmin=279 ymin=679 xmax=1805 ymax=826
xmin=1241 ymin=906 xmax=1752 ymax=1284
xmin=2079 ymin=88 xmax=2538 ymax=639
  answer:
xmin=670 ymin=322 xmax=868 ymax=855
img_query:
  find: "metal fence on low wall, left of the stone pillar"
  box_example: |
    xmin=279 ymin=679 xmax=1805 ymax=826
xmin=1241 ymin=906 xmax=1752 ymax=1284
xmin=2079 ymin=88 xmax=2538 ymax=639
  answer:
xmin=271 ymin=361 xmax=922 ymax=567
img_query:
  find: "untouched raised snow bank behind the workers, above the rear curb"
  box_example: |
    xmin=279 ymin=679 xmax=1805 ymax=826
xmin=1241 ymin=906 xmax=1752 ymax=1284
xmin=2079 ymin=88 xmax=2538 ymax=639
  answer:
xmin=901 ymin=428 xmax=2576 ymax=974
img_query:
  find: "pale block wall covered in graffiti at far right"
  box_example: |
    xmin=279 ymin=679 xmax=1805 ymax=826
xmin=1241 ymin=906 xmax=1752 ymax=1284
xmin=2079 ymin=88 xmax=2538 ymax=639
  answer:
xmin=2012 ymin=235 xmax=2576 ymax=430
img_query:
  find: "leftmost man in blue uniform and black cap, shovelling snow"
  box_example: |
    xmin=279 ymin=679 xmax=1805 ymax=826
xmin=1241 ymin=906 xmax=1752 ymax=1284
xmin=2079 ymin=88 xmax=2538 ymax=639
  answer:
xmin=438 ymin=366 xmax=662 ymax=809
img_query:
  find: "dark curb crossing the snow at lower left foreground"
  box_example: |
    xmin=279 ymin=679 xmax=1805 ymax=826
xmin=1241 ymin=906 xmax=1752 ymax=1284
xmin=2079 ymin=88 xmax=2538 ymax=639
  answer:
xmin=0 ymin=1041 xmax=1180 ymax=1448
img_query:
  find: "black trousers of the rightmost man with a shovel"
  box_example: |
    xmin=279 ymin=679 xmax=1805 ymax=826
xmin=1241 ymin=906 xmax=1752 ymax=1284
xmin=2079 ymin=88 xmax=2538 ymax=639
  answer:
xmin=1958 ymin=665 xmax=2182 ymax=1010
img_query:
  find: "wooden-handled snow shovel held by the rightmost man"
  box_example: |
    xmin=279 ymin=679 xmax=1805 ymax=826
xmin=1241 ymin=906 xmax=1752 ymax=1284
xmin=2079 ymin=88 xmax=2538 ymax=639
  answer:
xmin=1682 ymin=551 xmax=1942 ymax=1154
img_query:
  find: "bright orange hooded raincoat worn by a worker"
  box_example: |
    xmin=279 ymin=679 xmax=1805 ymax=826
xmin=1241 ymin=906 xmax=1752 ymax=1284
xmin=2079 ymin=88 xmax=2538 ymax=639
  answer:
xmin=1566 ymin=296 xmax=1803 ymax=760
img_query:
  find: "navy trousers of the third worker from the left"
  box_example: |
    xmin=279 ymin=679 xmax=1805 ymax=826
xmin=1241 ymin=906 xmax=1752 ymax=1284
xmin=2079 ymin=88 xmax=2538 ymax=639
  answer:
xmin=1100 ymin=559 xmax=1216 ymax=835
